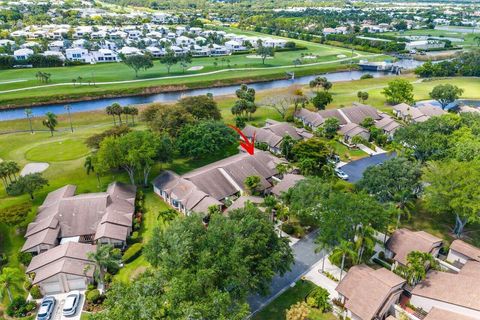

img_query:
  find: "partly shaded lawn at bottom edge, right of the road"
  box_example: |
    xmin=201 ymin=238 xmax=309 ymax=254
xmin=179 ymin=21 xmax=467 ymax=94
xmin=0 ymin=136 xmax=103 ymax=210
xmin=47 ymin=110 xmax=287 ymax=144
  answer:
xmin=252 ymin=281 xmax=337 ymax=320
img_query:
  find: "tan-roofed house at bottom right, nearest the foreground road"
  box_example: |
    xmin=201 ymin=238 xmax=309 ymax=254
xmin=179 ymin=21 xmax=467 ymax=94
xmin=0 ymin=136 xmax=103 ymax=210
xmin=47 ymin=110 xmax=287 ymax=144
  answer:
xmin=335 ymin=265 xmax=406 ymax=320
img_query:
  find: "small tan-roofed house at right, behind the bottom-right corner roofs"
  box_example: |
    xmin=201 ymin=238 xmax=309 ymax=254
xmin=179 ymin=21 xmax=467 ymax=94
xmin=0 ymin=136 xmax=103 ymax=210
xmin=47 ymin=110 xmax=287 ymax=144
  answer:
xmin=386 ymin=228 xmax=443 ymax=265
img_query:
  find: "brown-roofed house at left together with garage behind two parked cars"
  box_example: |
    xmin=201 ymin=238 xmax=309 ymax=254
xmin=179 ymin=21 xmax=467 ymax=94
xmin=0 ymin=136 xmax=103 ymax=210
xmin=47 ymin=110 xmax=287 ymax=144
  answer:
xmin=22 ymin=182 xmax=136 ymax=294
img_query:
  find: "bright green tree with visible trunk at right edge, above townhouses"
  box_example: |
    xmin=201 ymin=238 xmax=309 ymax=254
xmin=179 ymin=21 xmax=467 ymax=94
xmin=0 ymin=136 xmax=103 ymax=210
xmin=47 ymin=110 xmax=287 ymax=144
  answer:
xmin=422 ymin=160 xmax=480 ymax=238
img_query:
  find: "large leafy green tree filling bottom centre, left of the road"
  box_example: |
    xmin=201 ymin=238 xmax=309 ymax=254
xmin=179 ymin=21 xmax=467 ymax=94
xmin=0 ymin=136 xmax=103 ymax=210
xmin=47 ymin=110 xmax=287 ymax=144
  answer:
xmin=94 ymin=205 xmax=293 ymax=320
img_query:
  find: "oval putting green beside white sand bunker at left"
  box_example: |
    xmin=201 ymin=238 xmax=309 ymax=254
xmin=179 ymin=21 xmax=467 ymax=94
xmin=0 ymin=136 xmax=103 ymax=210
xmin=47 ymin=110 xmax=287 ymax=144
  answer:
xmin=25 ymin=139 xmax=89 ymax=162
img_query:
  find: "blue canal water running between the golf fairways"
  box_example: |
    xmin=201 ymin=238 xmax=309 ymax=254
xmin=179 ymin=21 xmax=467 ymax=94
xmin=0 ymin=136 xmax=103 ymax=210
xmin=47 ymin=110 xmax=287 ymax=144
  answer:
xmin=0 ymin=60 xmax=421 ymax=121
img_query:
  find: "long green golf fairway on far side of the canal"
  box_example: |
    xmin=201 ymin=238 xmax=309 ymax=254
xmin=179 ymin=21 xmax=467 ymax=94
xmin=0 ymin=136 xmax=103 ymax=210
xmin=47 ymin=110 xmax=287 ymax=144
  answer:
xmin=0 ymin=27 xmax=385 ymax=106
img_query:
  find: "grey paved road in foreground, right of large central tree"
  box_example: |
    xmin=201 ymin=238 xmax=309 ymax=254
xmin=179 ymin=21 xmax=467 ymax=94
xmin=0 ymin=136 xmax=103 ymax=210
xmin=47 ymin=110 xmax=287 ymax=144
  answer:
xmin=248 ymin=232 xmax=323 ymax=313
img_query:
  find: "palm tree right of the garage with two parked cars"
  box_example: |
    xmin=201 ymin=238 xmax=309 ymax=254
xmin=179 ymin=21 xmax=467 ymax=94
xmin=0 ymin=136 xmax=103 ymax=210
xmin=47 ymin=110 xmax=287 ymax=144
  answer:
xmin=88 ymin=244 xmax=122 ymax=283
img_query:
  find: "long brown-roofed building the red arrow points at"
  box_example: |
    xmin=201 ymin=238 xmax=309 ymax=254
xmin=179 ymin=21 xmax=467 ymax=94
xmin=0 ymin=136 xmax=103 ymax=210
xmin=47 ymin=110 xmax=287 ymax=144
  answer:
xmin=153 ymin=150 xmax=283 ymax=214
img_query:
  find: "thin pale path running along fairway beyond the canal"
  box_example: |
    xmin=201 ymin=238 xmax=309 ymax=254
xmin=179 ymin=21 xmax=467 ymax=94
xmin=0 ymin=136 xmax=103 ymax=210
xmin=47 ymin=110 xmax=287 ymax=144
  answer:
xmin=0 ymin=53 xmax=381 ymax=93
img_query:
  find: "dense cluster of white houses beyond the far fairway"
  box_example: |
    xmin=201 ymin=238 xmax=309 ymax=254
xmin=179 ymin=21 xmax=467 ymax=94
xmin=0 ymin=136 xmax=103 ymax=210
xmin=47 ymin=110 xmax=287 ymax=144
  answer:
xmin=0 ymin=20 xmax=287 ymax=64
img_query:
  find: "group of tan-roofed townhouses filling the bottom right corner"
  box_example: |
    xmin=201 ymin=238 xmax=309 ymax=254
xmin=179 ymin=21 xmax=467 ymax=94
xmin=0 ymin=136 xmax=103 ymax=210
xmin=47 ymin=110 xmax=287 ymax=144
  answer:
xmin=336 ymin=229 xmax=480 ymax=320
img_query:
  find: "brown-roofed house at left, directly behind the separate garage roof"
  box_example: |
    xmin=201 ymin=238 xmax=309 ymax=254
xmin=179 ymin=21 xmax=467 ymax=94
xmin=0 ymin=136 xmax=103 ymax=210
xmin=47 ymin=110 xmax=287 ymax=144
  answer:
xmin=22 ymin=182 xmax=136 ymax=254
